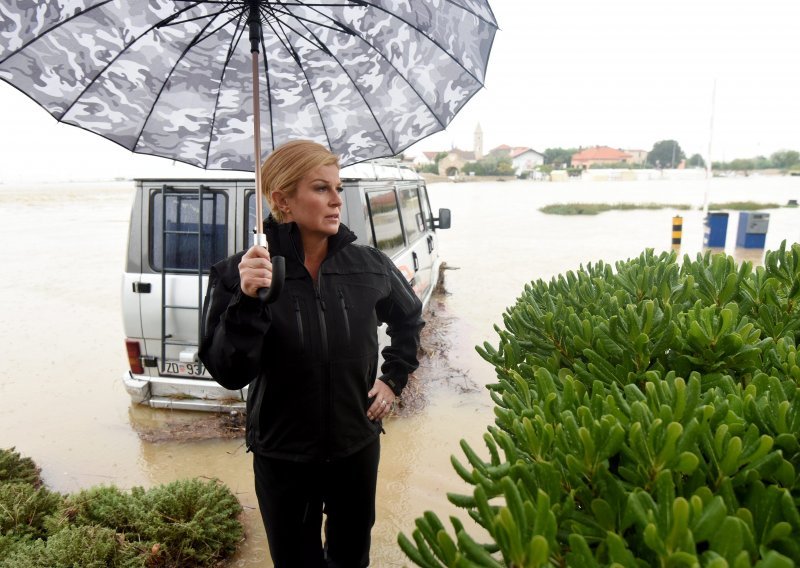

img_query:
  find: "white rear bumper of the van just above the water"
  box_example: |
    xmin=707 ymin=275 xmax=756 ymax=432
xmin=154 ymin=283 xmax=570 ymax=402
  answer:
xmin=122 ymin=371 xmax=247 ymax=412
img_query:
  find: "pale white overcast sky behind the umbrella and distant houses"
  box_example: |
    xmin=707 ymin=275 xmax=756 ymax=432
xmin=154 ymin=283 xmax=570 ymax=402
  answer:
xmin=0 ymin=0 xmax=800 ymax=182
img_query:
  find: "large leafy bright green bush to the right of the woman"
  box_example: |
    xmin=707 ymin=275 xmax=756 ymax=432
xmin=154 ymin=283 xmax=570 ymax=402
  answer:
xmin=398 ymin=243 xmax=800 ymax=568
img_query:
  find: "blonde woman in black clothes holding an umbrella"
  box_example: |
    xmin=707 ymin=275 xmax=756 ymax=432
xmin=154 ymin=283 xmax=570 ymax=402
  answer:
xmin=200 ymin=141 xmax=424 ymax=568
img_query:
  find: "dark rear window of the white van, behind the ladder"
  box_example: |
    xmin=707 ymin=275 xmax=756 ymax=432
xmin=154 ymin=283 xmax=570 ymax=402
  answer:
xmin=150 ymin=191 xmax=228 ymax=272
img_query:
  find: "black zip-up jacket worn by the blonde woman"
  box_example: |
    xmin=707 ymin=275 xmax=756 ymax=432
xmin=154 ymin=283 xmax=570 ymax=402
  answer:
xmin=200 ymin=218 xmax=424 ymax=462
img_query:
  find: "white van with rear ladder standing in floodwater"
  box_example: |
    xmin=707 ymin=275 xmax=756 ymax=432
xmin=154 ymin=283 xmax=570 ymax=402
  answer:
xmin=122 ymin=162 xmax=450 ymax=411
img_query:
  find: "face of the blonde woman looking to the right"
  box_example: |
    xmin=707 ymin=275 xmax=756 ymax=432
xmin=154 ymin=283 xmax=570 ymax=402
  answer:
xmin=284 ymin=165 xmax=342 ymax=237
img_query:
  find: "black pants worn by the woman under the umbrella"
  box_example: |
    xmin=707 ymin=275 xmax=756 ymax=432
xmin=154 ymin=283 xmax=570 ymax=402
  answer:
xmin=253 ymin=439 xmax=380 ymax=568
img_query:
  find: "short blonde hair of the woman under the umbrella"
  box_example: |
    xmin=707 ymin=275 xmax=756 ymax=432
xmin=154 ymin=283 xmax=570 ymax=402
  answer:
xmin=261 ymin=140 xmax=339 ymax=223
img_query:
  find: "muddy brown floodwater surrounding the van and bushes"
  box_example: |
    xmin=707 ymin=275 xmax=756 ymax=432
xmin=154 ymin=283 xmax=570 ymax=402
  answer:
xmin=0 ymin=176 xmax=800 ymax=567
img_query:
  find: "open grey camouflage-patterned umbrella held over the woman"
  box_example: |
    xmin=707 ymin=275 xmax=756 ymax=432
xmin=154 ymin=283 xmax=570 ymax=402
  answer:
xmin=0 ymin=0 xmax=497 ymax=298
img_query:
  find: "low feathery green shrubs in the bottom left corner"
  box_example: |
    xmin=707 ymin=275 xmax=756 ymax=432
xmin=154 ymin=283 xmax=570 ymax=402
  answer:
xmin=0 ymin=448 xmax=243 ymax=568
